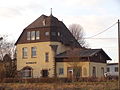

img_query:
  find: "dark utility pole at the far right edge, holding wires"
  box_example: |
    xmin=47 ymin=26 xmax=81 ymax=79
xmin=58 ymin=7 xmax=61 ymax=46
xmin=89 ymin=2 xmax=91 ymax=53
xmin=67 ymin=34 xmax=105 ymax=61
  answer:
xmin=118 ymin=19 xmax=120 ymax=90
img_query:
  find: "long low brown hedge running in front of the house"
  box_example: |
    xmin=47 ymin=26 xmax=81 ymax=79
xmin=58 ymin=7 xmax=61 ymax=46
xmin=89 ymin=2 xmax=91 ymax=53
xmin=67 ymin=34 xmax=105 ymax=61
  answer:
xmin=1 ymin=77 xmax=118 ymax=83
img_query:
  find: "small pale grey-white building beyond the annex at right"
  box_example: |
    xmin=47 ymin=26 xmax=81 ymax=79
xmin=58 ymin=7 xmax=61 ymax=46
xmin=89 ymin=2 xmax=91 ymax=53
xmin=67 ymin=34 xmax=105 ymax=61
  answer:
xmin=107 ymin=63 xmax=119 ymax=76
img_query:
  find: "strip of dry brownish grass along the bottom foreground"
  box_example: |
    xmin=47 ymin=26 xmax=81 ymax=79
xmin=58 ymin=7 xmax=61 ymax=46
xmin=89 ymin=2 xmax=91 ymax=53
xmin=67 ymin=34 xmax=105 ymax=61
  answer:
xmin=0 ymin=81 xmax=119 ymax=90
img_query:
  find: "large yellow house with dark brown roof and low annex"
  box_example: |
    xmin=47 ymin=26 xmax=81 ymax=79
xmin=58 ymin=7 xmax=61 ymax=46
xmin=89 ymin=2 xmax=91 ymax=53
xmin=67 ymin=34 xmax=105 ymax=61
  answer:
xmin=16 ymin=14 xmax=111 ymax=78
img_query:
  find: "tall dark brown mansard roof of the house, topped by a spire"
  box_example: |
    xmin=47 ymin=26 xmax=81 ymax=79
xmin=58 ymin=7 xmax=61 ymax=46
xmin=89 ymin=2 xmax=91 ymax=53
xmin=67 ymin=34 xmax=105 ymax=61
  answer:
xmin=15 ymin=15 xmax=81 ymax=47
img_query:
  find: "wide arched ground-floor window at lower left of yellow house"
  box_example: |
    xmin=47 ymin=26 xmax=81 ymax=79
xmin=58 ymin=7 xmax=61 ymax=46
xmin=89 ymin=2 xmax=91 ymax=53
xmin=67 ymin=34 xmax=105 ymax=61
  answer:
xmin=22 ymin=66 xmax=33 ymax=77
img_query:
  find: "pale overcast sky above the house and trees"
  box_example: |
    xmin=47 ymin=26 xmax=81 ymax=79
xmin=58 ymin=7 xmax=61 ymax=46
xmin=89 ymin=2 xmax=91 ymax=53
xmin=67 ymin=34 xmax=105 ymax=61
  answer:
xmin=0 ymin=0 xmax=120 ymax=62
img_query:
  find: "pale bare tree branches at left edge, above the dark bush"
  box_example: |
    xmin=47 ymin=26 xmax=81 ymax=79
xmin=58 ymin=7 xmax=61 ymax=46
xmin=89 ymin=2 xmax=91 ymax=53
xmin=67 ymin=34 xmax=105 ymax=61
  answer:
xmin=0 ymin=35 xmax=15 ymax=60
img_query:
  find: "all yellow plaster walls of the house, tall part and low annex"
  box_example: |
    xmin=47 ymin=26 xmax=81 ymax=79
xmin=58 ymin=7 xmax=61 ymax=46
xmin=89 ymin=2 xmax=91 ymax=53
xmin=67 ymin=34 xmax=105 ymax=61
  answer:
xmin=17 ymin=42 xmax=106 ymax=78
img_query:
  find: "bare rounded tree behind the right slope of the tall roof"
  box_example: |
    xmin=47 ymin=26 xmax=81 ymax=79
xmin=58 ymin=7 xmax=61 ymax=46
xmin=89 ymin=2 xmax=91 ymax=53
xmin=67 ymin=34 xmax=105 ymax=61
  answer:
xmin=69 ymin=24 xmax=87 ymax=47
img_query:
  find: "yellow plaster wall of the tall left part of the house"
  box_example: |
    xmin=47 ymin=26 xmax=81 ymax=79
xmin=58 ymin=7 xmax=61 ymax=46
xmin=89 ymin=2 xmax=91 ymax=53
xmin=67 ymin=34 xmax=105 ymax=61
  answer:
xmin=17 ymin=42 xmax=69 ymax=78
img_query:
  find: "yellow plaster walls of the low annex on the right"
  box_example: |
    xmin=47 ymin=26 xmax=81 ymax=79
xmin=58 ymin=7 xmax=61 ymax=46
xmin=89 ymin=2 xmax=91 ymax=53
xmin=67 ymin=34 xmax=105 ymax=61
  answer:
xmin=57 ymin=62 xmax=106 ymax=78
